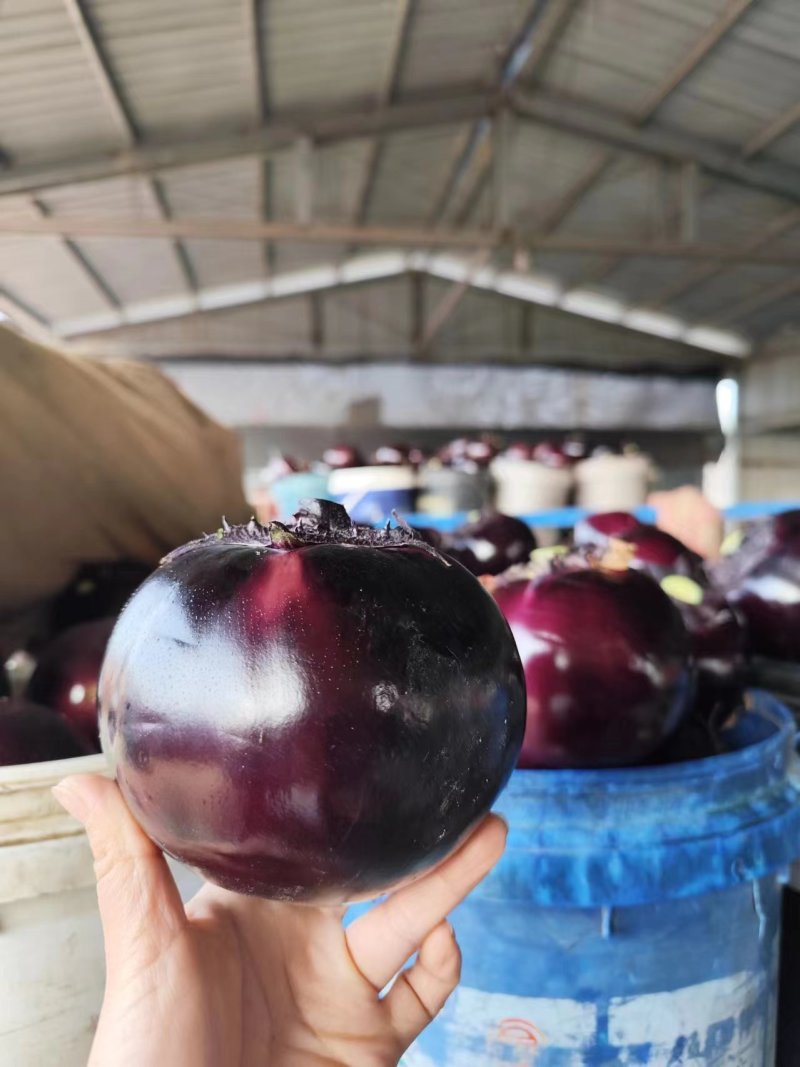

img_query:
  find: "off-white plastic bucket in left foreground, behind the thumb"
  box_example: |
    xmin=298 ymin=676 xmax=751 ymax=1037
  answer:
xmin=0 ymin=755 xmax=201 ymax=1067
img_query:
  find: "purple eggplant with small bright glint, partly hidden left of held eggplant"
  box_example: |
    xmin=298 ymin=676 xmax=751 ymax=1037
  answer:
xmin=26 ymin=619 xmax=114 ymax=752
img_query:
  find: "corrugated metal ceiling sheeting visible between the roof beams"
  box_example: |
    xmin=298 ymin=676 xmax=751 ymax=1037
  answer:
xmin=0 ymin=0 xmax=800 ymax=361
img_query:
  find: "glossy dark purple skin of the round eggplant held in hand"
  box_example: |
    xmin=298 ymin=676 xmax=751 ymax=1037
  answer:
xmin=100 ymin=541 xmax=525 ymax=903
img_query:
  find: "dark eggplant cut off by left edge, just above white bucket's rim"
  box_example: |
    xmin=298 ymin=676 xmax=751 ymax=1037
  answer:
xmin=0 ymin=700 xmax=92 ymax=767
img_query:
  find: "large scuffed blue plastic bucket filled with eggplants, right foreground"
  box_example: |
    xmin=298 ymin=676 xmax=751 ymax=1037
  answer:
xmin=402 ymin=692 xmax=800 ymax=1067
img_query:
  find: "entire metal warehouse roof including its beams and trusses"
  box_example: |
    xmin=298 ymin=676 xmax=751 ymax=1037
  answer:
xmin=0 ymin=0 xmax=800 ymax=368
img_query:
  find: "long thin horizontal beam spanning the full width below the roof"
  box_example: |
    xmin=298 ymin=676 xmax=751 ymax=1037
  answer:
xmin=0 ymin=216 xmax=800 ymax=267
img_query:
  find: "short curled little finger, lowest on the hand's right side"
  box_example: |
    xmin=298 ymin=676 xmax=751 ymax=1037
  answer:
xmin=384 ymin=922 xmax=461 ymax=1050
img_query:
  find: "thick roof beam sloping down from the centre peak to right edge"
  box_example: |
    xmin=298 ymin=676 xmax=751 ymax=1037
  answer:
xmin=512 ymin=92 xmax=800 ymax=202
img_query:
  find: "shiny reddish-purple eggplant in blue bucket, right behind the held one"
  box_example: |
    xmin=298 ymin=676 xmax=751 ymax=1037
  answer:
xmin=495 ymin=568 xmax=693 ymax=767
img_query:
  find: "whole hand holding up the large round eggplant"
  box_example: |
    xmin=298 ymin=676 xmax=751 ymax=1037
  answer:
xmin=53 ymin=775 xmax=506 ymax=1067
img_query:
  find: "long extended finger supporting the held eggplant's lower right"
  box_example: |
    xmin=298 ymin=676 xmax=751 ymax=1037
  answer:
xmin=346 ymin=815 xmax=508 ymax=989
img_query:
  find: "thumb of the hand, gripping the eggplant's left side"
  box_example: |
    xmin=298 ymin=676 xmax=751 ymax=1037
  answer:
xmin=52 ymin=775 xmax=186 ymax=982
